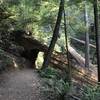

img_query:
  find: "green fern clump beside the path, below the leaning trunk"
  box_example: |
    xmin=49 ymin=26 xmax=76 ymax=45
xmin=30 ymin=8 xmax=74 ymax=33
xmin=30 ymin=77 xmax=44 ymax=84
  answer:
xmin=40 ymin=67 xmax=70 ymax=95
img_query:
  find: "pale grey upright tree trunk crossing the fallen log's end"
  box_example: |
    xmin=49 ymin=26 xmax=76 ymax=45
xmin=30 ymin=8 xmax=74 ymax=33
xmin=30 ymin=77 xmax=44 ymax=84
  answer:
xmin=84 ymin=1 xmax=90 ymax=68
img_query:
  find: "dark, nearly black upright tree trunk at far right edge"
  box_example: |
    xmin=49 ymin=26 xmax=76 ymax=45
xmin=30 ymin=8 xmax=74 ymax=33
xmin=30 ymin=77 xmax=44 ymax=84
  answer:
xmin=93 ymin=0 xmax=100 ymax=82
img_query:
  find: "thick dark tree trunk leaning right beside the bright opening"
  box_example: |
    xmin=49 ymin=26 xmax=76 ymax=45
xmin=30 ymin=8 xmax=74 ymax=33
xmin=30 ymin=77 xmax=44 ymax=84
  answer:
xmin=42 ymin=0 xmax=64 ymax=68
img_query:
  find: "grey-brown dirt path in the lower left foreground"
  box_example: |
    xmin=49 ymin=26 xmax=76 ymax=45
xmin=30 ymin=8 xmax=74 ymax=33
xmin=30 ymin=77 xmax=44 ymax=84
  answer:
xmin=0 ymin=69 xmax=45 ymax=100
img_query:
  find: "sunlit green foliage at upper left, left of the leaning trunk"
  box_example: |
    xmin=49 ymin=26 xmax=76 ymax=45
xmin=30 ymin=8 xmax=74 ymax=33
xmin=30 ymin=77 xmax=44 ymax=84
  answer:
xmin=0 ymin=0 xmax=59 ymax=42
